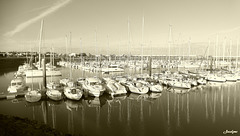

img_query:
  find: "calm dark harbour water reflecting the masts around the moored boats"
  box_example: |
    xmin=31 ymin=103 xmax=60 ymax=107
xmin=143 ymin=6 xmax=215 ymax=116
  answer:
xmin=0 ymin=64 xmax=240 ymax=136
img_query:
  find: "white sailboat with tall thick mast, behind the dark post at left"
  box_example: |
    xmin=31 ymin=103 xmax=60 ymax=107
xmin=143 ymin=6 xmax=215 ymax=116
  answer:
xmin=25 ymin=20 xmax=62 ymax=77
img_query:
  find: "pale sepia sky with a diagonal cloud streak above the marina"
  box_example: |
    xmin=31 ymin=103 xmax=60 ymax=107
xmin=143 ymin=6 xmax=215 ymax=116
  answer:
xmin=0 ymin=0 xmax=240 ymax=55
